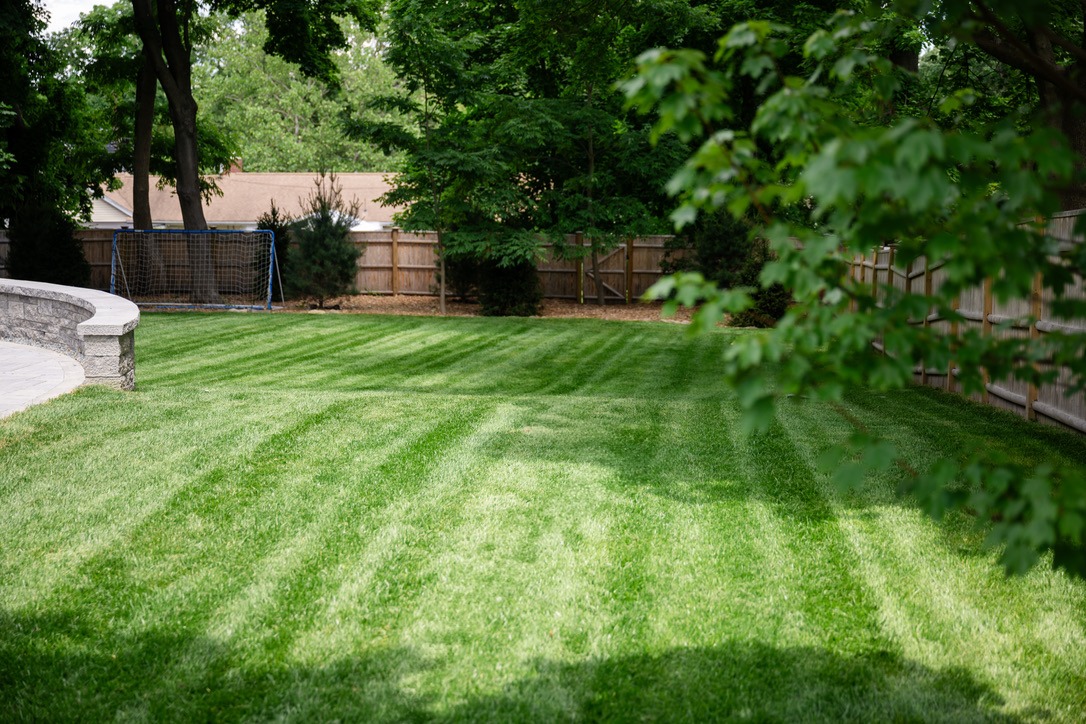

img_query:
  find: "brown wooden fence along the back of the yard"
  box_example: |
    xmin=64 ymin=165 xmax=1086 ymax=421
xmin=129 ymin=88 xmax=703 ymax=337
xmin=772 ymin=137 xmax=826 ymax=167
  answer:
xmin=0 ymin=229 xmax=670 ymax=303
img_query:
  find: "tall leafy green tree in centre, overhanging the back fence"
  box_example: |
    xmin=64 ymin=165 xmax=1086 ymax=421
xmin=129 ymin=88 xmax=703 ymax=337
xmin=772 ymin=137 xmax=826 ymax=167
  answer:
xmin=377 ymin=0 xmax=716 ymax=308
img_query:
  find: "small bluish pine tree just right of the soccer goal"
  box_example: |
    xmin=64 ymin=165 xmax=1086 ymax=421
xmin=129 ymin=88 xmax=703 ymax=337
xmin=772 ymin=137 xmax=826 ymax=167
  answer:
xmin=286 ymin=174 xmax=362 ymax=308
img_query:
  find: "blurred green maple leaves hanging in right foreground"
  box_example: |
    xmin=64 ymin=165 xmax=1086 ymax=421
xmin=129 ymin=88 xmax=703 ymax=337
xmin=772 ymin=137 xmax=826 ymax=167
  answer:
xmin=626 ymin=3 xmax=1086 ymax=573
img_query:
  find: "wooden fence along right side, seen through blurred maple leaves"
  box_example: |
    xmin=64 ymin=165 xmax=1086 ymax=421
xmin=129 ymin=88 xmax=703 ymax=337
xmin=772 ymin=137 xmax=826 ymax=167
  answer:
xmin=850 ymin=209 xmax=1086 ymax=432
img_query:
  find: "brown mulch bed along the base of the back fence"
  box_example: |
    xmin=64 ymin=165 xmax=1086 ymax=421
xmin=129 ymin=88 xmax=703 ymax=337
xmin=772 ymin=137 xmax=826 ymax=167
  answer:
xmin=282 ymin=294 xmax=691 ymax=323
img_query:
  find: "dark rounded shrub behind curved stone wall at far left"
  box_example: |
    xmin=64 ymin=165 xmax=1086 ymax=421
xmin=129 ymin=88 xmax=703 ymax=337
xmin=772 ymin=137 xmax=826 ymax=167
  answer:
xmin=8 ymin=199 xmax=90 ymax=287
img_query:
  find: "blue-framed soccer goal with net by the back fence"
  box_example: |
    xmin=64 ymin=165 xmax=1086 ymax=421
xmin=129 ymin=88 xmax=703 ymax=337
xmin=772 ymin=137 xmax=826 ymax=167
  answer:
xmin=110 ymin=230 xmax=276 ymax=309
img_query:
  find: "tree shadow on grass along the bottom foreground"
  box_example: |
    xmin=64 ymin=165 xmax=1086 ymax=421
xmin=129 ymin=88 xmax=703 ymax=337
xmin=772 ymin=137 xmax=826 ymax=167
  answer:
xmin=0 ymin=614 xmax=1020 ymax=722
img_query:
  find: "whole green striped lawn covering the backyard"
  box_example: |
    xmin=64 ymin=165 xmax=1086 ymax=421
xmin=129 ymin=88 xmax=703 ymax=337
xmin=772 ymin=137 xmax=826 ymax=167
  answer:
xmin=0 ymin=314 xmax=1086 ymax=722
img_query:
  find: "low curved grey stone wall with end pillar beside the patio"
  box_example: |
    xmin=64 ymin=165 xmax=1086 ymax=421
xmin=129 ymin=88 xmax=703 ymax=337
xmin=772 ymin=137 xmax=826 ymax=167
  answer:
xmin=0 ymin=279 xmax=139 ymax=390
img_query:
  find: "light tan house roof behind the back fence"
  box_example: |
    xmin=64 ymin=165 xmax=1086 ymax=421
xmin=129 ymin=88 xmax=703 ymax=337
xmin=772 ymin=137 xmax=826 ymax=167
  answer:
xmin=105 ymin=172 xmax=402 ymax=226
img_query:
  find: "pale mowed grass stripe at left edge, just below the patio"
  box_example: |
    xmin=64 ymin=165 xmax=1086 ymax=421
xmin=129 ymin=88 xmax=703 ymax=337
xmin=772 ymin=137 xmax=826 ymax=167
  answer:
xmin=0 ymin=389 xmax=292 ymax=596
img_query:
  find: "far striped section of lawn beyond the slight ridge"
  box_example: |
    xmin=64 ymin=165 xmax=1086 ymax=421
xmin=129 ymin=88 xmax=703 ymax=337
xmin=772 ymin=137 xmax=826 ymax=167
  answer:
xmin=139 ymin=314 xmax=723 ymax=396
